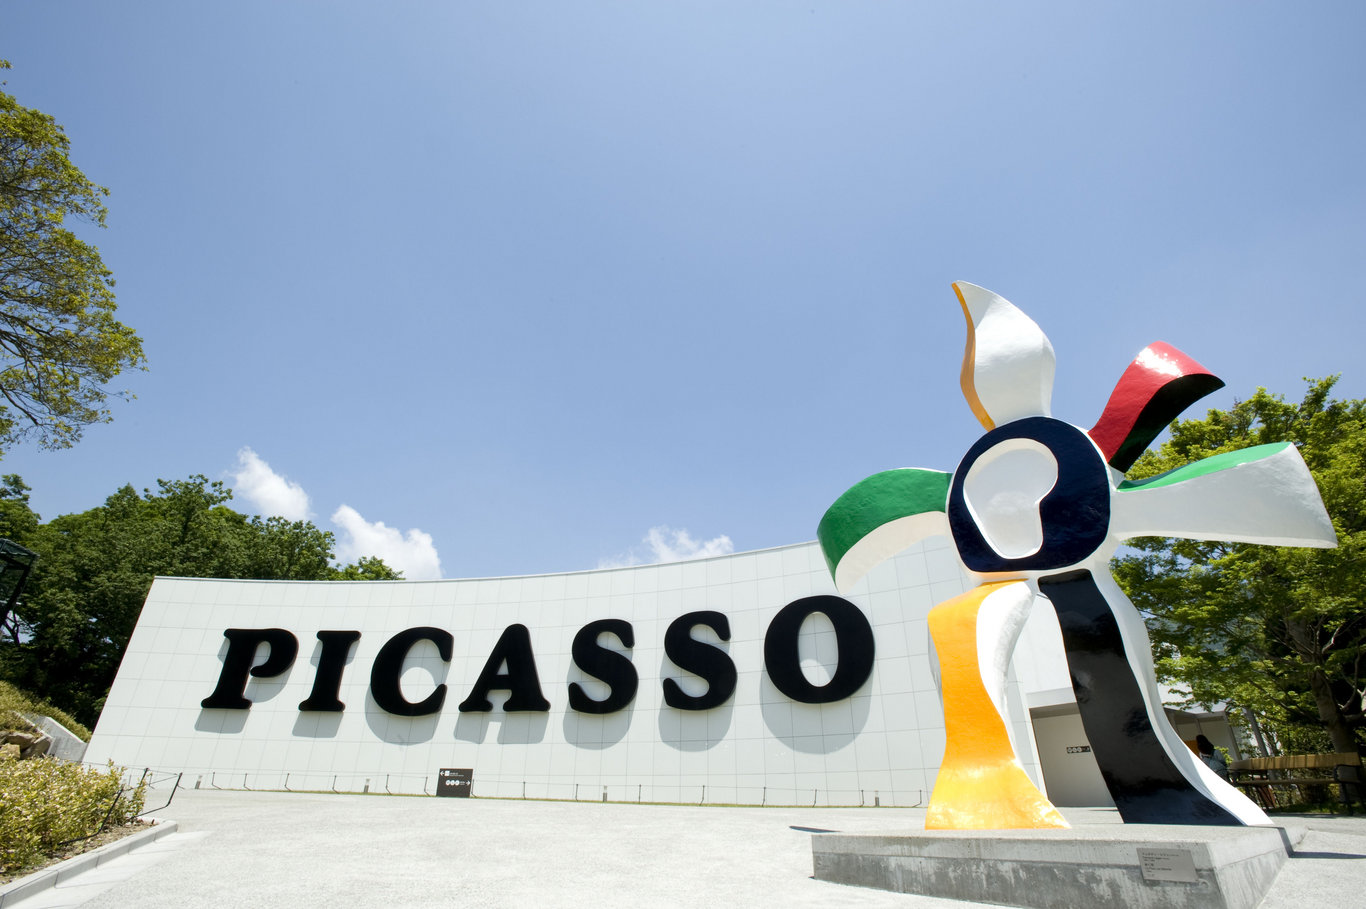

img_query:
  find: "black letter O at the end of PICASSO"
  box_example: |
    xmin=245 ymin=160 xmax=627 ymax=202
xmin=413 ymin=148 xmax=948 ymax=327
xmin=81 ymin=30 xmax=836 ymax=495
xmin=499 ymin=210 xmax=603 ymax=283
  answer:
xmin=764 ymin=596 xmax=874 ymax=704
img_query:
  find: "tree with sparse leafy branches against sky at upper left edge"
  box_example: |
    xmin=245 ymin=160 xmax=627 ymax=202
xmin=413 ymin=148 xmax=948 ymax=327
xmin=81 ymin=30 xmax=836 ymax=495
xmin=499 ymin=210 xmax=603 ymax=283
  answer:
xmin=0 ymin=60 xmax=145 ymax=451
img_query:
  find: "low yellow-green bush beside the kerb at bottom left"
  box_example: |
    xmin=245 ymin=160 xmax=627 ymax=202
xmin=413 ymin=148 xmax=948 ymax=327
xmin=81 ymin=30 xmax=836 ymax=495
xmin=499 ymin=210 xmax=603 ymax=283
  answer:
xmin=0 ymin=757 xmax=145 ymax=873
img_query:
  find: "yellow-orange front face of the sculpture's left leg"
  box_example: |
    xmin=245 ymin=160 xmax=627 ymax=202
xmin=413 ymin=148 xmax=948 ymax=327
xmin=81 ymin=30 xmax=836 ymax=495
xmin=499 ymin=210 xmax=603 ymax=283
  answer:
xmin=925 ymin=581 xmax=1068 ymax=830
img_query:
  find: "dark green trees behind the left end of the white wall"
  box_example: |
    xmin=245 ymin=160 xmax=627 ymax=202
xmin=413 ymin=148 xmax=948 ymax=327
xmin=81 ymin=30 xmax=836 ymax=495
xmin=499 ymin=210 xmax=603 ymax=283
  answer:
xmin=0 ymin=476 xmax=402 ymax=726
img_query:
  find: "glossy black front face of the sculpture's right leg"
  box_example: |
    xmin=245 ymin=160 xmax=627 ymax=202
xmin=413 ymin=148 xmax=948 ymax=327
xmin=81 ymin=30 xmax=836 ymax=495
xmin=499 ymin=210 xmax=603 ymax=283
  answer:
xmin=1038 ymin=570 xmax=1240 ymax=826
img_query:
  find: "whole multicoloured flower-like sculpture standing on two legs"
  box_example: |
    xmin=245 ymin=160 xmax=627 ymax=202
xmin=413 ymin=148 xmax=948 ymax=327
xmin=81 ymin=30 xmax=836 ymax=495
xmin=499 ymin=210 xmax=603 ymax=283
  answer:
xmin=817 ymin=283 xmax=1337 ymax=830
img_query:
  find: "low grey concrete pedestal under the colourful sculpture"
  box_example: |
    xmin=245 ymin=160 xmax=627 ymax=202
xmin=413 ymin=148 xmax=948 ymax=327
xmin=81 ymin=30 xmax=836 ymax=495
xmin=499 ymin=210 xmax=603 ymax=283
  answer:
xmin=811 ymin=824 xmax=1305 ymax=909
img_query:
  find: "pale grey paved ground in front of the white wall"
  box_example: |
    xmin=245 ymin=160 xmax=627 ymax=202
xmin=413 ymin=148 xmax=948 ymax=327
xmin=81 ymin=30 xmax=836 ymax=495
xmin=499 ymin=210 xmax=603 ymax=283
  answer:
xmin=8 ymin=790 xmax=1366 ymax=909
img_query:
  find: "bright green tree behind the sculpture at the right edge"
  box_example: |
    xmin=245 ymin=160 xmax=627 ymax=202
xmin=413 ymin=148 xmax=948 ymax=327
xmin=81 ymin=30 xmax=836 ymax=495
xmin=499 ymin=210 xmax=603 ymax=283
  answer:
xmin=1115 ymin=376 xmax=1366 ymax=752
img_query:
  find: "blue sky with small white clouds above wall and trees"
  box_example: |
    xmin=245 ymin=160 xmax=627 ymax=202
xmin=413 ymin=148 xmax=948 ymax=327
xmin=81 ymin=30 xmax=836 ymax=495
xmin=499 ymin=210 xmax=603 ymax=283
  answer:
xmin=0 ymin=0 xmax=1366 ymax=577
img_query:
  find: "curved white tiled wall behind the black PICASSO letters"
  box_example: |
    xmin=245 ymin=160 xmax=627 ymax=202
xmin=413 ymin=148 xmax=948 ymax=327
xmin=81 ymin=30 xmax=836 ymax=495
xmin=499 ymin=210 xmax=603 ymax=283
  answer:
xmin=86 ymin=539 xmax=1043 ymax=805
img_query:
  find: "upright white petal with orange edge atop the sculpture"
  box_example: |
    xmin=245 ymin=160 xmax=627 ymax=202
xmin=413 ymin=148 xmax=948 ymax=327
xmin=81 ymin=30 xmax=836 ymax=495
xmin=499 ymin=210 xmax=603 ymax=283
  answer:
xmin=953 ymin=282 xmax=1056 ymax=429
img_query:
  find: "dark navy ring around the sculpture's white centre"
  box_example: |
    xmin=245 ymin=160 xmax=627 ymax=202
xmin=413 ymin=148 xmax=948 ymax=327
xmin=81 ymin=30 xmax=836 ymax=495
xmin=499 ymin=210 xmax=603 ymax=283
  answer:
xmin=948 ymin=417 xmax=1111 ymax=573
